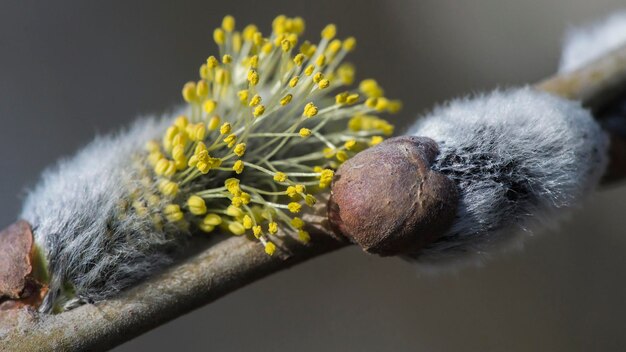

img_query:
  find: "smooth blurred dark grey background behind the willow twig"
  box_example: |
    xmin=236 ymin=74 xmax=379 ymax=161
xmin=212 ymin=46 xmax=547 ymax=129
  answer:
xmin=0 ymin=0 xmax=626 ymax=352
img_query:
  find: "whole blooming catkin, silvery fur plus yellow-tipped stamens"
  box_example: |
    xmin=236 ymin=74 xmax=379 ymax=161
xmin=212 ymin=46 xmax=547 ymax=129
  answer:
xmin=22 ymin=16 xmax=400 ymax=312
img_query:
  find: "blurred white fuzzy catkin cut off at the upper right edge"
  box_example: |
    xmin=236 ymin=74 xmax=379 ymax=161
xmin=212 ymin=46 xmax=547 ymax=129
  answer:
xmin=559 ymin=11 xmax=626 ymax=72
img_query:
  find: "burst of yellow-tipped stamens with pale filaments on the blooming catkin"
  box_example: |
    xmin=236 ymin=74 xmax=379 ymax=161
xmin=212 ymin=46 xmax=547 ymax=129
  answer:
xmin=135 ymin=15 xmax=401 ymax=255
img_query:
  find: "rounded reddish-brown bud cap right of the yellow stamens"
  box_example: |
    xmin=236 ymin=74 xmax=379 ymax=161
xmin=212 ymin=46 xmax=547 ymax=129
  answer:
xmin=328 ymin=136 xmax=458 ymax=256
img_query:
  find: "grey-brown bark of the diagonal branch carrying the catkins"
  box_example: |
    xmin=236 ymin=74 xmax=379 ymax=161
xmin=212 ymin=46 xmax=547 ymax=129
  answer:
xmin=0 ymin=47 xmax=626 ymax=351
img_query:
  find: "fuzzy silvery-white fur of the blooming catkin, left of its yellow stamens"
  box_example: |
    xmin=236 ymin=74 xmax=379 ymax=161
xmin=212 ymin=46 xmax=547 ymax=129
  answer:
xmin=21 ymin=113 xmax=179 ymax=311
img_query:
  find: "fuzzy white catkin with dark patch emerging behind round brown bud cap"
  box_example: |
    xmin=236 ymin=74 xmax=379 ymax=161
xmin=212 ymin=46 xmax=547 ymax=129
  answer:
xmin=408 ymin=87 xmax=608 ymax=268
